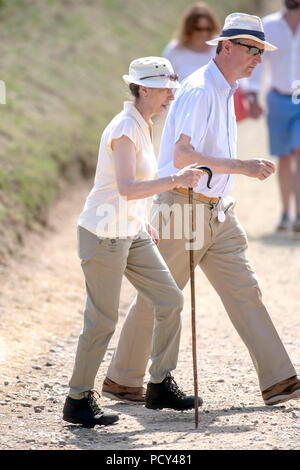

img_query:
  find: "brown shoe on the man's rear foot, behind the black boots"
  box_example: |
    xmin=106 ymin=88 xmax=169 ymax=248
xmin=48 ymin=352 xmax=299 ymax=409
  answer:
xmin=102 ymin=377 xmax=146 ymax=405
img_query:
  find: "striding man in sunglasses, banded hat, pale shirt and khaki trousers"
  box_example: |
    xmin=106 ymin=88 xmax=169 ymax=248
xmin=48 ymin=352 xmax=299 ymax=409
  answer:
xmin=102 ymin=13 xmax=300 ymax=406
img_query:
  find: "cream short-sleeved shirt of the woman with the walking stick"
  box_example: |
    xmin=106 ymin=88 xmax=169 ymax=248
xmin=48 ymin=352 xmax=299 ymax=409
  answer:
xmin=78 ymin=102 xmax=157 ymax=238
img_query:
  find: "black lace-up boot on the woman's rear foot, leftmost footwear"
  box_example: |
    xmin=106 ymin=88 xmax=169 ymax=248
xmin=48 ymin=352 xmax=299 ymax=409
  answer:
xmin=63 ymin=390 xmax=119 ymax=428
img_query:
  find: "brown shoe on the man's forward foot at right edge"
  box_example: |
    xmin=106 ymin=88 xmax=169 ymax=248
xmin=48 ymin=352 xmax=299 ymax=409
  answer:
xmin=262 ymin=375 xmax=300 ymax=405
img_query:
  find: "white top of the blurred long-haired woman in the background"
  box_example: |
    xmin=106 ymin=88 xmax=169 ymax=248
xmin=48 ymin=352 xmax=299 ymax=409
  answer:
xmin=163 ymin=39 xmax=216 ymax=82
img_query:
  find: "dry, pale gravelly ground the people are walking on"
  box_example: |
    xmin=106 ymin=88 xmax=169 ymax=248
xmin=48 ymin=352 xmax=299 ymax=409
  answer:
xmin=0 ymin=114 xmax=300 ymax=450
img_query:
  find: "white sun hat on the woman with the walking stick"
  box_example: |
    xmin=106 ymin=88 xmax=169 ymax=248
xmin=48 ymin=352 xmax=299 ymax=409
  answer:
xmin=123 ymin=57 xmax=181 ymax=88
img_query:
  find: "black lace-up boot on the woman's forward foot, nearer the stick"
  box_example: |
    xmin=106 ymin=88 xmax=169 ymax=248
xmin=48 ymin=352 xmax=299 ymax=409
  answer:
xmin=145 ymin=374 xmax=203 ymax=410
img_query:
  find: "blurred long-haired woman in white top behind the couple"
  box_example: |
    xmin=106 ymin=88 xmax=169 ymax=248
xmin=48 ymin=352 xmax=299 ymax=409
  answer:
xmin=163 ymin=3 xmax=220 ymax=82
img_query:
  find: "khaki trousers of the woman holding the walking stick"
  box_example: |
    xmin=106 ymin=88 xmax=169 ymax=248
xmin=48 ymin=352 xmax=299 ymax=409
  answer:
xmin=69 ymin=227 xmax=183 ymax=399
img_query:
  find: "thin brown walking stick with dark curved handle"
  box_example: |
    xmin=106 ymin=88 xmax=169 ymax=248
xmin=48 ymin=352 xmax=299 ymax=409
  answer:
xmin=188 ymin=166 xmax=213 ymax=429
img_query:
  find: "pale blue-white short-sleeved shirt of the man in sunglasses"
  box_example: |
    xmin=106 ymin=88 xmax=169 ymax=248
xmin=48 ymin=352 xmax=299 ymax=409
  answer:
xmin=158 ymin=60 xmax=238 ymax=197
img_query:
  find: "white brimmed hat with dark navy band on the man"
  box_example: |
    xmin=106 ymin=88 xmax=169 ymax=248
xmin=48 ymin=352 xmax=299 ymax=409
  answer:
xmin=206 ymin=13 xmax=277 ymax=51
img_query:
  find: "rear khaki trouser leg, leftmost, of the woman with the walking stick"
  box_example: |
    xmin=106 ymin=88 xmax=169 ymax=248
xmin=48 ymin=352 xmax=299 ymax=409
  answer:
xmin=69 ymin=227 xmax=131 ymax=399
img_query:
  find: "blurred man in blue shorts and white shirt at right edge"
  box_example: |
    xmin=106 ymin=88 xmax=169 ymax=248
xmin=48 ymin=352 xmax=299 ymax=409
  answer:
xmin=248 ymin=0 xmax=300 ymax=232
